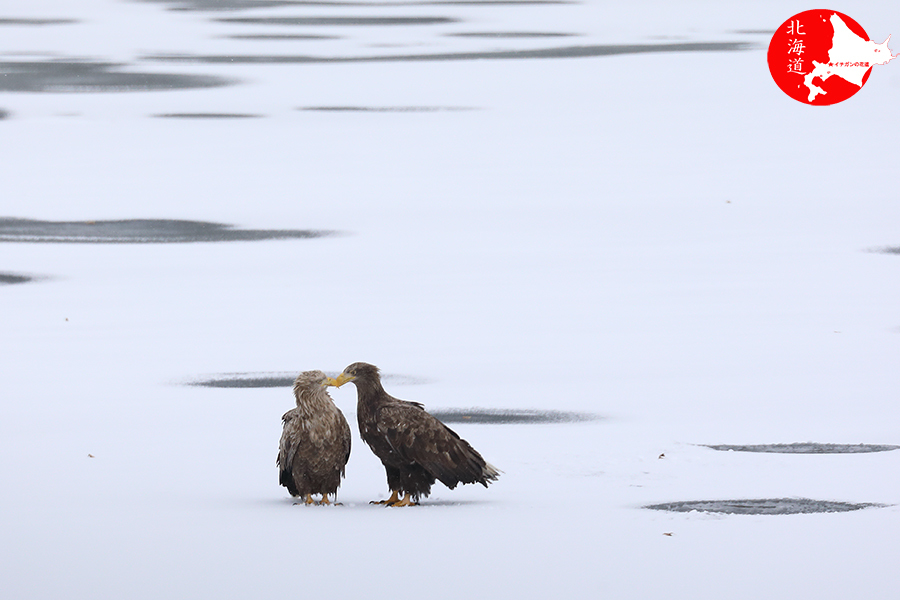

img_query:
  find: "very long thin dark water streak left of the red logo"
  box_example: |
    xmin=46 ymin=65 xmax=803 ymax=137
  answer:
xmin=144 ymin=42 xmax=756 ymax=64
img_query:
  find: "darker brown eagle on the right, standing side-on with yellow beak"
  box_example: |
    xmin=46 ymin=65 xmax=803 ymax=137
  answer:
xmin=329 ymin=363 xmax=500 ymax=506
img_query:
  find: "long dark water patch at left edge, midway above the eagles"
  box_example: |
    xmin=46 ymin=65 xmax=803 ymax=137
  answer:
xmin=0 ymin=218 xmax=337 ymax=244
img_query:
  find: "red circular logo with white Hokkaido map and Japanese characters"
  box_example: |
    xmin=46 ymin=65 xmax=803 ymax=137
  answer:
xmin=768 ymin=10 xmax=894 ymax=106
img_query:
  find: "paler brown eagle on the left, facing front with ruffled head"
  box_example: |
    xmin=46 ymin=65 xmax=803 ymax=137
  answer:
xmin=277 ymin=371 xmax=350 ymax=504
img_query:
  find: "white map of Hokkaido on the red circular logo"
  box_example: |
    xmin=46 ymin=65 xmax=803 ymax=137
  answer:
xmin=803 ymin=15 xmax=900 ymax=102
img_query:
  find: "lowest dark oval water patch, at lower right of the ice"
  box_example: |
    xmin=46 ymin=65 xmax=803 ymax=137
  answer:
xmin=644 ymin=498 xmax=886 ymax=515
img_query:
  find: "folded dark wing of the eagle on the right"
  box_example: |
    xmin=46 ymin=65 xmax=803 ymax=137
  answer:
xmin=376 ymin=401 xmax=496 ymax=489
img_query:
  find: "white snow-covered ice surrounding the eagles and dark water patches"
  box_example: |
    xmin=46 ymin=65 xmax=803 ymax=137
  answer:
xmin=0 ymin=0 xmax=900 ymax=600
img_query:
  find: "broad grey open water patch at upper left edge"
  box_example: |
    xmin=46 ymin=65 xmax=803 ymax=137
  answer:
xmin=0 ymin=60 xmax=236 ymax=93
